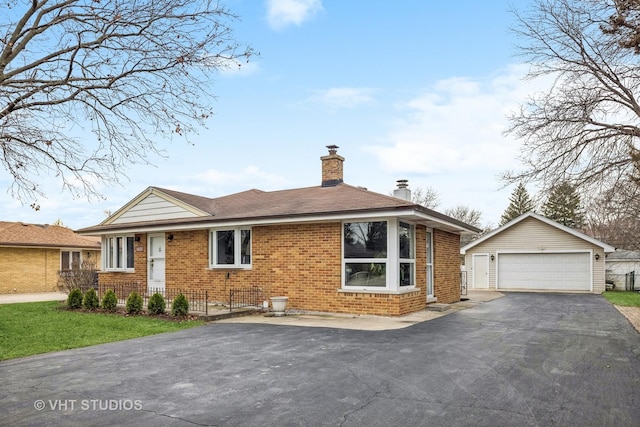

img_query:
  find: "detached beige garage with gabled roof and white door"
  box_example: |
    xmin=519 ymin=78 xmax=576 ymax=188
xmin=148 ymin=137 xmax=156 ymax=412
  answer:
xmin=461 ymin=212 xmax=615 ymax=293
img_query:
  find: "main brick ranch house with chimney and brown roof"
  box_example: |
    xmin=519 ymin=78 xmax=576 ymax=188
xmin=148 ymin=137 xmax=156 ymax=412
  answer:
xmin=78 ymin=146 xmax=480 ymax=316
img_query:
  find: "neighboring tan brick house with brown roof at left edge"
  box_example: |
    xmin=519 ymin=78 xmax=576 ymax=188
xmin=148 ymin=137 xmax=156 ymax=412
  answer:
xmin=0 ymin=222 xmax=100 ymax=294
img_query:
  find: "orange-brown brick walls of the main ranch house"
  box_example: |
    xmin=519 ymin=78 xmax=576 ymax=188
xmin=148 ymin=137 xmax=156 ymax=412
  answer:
xmin=100 ymin=222 xmax=460 ymax=316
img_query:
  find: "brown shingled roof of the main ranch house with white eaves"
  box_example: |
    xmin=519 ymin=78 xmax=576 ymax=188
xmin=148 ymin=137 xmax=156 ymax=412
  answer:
xmin=78 ymin=184 xmax=481 ymax=234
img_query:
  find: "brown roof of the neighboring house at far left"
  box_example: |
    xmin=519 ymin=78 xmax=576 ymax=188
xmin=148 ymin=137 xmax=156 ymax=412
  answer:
xmin=0 ymin=221 xmax=100 ymax=250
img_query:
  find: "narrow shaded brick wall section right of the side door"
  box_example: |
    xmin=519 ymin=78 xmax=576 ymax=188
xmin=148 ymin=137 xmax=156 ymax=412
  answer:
xmin=433 ymin=230 xmax=460 ymax=304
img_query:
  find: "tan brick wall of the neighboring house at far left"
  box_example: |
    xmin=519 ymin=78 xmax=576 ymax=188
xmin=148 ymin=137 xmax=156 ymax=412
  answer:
xmin=0 ymin=247 xmax=100 ymax=294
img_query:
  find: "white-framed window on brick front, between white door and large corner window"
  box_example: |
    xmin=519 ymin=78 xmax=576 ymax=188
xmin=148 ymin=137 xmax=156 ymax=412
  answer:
xmin=209 ymin=228 xmax=251 ymax=268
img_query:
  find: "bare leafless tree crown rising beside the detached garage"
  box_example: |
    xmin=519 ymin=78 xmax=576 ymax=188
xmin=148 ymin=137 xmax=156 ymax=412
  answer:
xmin=504 ymin=0 xmax=640 ymax=189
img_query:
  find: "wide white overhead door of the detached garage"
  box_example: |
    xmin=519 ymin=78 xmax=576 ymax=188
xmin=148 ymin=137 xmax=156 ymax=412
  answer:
xmin=497 ymin=252 xmax=592 ymax=291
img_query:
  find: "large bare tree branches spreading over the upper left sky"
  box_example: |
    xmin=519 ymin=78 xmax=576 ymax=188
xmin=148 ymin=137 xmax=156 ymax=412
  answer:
xmin=0 ymin=0 xmax=253 ymax=208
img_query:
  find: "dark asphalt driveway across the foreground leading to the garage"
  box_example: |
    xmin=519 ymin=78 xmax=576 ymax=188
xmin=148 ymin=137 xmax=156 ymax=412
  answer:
xmin=0 ymin=293 xmax=640 ymax=426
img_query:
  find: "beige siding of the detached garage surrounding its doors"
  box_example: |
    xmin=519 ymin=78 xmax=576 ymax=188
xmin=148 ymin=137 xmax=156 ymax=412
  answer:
xmin=465 ymin=217 xmax=604 ymax=293
